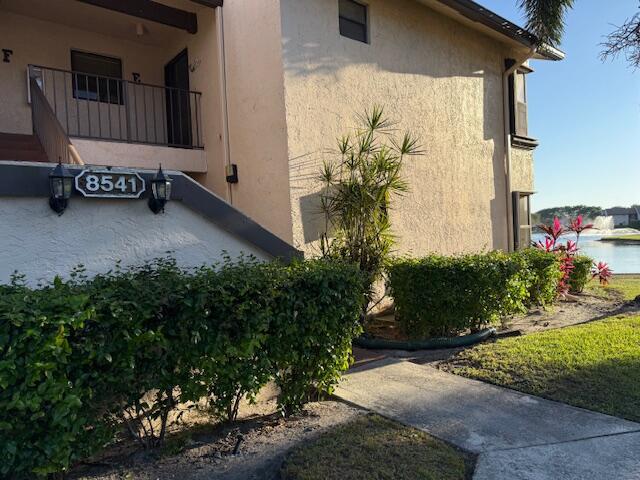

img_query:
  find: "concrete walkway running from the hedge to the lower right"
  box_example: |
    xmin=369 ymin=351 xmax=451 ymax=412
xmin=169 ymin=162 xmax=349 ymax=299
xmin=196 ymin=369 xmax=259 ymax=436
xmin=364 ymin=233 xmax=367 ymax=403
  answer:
xmin=336 ymin=359 xmax=640 ymax=480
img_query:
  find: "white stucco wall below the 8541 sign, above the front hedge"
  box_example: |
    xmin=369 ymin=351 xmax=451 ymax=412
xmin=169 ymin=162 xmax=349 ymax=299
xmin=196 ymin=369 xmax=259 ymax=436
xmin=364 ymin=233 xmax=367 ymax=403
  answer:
xmin=0 ymin=197 xmax=269 ymax=285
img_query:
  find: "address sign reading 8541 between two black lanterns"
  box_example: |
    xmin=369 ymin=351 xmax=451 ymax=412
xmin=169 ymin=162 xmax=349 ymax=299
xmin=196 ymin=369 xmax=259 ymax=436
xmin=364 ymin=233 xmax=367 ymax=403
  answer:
xmin=76 ymin=169 xmax=146 ymax=198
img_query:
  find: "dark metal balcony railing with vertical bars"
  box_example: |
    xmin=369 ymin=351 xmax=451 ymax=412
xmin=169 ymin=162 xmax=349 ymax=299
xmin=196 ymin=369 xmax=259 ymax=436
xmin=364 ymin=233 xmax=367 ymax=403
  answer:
xmin=29 ymin=65 xmax=204 ymax=149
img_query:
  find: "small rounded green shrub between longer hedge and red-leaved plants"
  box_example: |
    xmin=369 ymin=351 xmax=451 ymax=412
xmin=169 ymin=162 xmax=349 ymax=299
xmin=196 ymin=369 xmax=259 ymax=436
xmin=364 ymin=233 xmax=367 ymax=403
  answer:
xmin=514 ymin=248 xmax=562 ymax=305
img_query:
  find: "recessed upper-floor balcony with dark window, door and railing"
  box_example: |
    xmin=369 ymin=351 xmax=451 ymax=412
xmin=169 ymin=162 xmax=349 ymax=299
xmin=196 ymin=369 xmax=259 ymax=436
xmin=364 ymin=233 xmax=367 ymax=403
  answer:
xmin=0 ymin=0 xmax=219 ymax=173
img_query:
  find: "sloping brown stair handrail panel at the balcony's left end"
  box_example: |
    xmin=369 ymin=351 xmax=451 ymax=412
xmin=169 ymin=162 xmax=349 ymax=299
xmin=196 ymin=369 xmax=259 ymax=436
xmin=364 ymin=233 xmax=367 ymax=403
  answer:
xmin=29 ymin=76 xmax=84 ymax=165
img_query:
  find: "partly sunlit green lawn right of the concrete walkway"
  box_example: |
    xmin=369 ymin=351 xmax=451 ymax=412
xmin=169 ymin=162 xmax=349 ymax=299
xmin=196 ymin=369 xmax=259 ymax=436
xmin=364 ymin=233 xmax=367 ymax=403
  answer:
xmin=449 ymin=315 xmax=640 ymax=421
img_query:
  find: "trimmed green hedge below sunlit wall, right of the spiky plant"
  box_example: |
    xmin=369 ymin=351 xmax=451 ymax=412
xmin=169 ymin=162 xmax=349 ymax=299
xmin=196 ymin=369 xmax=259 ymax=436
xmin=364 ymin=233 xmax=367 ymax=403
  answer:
xmin=389 ymin=252 xmax=530 ymax=339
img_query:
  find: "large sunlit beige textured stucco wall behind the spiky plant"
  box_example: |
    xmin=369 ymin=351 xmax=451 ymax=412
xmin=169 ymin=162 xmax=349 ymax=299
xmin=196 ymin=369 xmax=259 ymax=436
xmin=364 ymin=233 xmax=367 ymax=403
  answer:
xmin=282 ymin=0 xmax=524 ymax=255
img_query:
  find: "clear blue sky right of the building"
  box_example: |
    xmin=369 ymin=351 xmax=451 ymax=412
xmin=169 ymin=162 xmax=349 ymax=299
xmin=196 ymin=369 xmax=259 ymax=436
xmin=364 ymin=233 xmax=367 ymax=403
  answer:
xmin=477 ymin=0 xmax=640 ymax=211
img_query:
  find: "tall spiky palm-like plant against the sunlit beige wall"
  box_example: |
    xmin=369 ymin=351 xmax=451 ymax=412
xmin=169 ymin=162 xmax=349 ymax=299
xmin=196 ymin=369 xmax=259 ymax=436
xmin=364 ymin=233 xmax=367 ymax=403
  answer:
xmin=320 ymin=106 xmax=421 ymax=308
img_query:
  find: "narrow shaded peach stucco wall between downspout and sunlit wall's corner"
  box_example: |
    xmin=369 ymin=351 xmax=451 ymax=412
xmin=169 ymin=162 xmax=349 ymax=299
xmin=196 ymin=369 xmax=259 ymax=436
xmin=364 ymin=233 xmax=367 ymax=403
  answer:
xmin=216 ymin=0 xmax=294 ymax=242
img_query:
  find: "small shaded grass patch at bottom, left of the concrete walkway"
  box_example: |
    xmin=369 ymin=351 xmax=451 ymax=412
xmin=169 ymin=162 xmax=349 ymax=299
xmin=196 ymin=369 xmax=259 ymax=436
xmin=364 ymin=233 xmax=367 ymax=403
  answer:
xmin=281 ymin=415 xmax=473 ymax=480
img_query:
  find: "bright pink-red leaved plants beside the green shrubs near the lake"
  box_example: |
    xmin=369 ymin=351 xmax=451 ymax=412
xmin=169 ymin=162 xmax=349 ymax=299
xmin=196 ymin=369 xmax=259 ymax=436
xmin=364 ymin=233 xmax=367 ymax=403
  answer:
xmin=534 ymin=215 xmax=613 ymax=296
